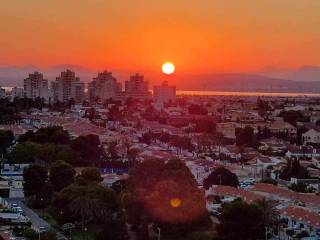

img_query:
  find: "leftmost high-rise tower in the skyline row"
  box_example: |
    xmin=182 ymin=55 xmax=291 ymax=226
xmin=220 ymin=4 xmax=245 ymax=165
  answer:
xmin=23 ymin=72 xmax=49 ymax=101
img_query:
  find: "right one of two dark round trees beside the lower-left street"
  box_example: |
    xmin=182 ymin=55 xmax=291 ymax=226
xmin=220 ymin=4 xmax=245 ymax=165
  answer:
xmin=49 ymin=161 xmax=76 ymax=192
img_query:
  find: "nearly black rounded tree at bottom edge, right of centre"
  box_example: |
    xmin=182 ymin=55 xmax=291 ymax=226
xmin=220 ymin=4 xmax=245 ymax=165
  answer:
xmin=217 ymin=200 xmax=265 ymax=240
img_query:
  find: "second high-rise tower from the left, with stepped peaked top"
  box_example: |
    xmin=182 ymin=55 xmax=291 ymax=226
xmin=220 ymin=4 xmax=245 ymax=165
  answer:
xmin=51 ymin=69 xmax=84 ymax=103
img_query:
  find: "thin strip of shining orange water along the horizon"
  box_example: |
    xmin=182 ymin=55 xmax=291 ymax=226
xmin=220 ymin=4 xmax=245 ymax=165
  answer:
xmin=177 ymin=91 xmax=320 ymax=97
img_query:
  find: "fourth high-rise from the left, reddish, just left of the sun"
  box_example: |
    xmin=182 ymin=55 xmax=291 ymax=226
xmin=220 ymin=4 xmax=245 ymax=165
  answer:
xmin=125 ymin=73 xmax=150 ymax=97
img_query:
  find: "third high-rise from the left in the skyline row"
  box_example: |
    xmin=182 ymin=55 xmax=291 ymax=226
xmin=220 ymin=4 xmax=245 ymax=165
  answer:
xmin=88 ymin=71 xmax=122 ymax=101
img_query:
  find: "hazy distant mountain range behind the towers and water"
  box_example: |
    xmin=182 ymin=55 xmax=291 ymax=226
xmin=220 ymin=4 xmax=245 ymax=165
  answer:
xmin=0 ymin=64 xmax=320 ymax=93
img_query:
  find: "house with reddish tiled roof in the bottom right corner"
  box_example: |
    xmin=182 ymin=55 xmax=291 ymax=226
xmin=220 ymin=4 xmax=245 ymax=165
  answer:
xmin=280 ymin=206 xmax=320 ymax=240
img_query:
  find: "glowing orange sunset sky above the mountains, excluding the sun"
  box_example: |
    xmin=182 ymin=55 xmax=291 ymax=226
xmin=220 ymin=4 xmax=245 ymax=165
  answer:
xmin=0 ymin=0 xmax=320 ymax=73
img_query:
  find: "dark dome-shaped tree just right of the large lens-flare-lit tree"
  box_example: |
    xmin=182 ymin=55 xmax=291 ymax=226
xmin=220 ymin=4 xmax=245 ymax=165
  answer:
xmin=203 ymin=167 xmax=239 ymax=189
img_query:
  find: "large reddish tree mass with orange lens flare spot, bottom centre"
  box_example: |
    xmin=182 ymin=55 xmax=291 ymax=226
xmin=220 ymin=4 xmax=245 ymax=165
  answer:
xmin=125 ymin=159 xmax=210 ymax=239
